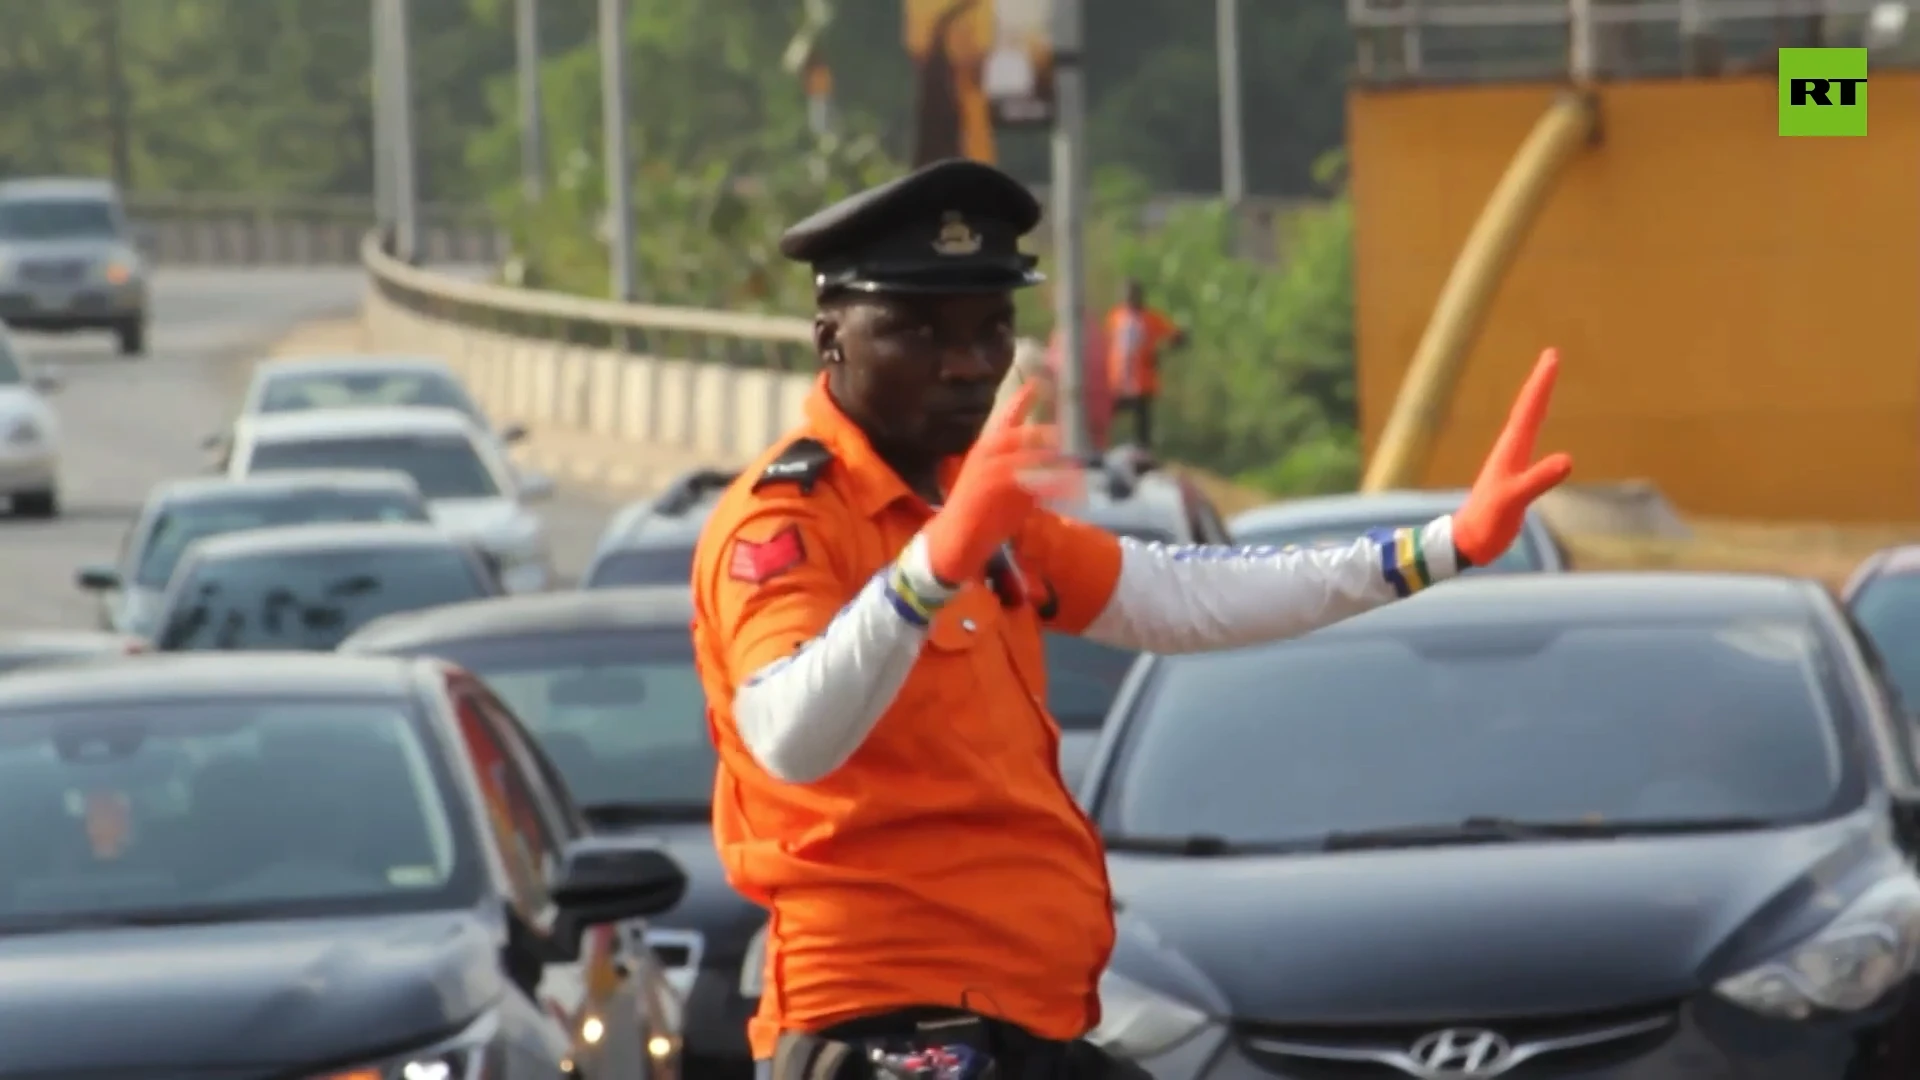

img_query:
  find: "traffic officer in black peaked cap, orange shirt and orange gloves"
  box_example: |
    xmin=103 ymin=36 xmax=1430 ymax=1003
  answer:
xmin=693 ymin=160 xmax=1571 ymax=1080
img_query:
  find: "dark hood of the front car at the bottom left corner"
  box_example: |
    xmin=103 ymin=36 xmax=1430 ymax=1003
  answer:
xmin=0 ymin=913 xmax=501 ymax=1076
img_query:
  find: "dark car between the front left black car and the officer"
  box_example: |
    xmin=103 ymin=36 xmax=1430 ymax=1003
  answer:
xmin=340 ymin=584 xmax=766 ymax=1080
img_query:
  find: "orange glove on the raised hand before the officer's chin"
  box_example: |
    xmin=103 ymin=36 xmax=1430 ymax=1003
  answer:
xmin=922 ymin=382 xmax=1071 ymax=584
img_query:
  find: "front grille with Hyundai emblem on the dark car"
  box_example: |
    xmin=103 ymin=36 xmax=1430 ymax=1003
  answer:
xmin=1235 ymin=1003 xmax=1678 ymax=1080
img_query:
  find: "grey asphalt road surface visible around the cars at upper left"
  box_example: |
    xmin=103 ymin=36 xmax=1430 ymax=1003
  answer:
xmin=0 ymin=267 xmax=609 ymax=630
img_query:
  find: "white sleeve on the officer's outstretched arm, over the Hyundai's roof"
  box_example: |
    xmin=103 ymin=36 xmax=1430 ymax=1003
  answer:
xmin=1085 ymin=517 xmax=1461 ymax=653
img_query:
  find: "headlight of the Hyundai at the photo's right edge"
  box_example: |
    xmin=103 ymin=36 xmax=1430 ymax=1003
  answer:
xmin=1715 ymin=874 xmax=1920 ymax=1020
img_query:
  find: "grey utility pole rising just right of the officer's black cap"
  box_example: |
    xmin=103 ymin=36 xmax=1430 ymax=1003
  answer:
xmin=1050 ymin=0 xmax=1094 ymax=457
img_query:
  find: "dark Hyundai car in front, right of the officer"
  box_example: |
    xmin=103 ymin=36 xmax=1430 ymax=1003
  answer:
xmin=1083 ymin=573 xmax=1920 ymax=1080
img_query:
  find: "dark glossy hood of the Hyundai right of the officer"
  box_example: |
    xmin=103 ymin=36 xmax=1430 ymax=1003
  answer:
xmin=1110 ymin=819 xmax=1878 ymax=1024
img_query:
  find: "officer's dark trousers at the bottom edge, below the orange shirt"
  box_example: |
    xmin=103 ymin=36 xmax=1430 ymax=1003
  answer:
xmin=755 ymin=1007 xmax=1148 ymax=1080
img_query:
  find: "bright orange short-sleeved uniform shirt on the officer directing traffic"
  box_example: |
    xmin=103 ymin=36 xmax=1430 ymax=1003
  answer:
xmin=693 ymin=380 xmax=1121 ymax=1059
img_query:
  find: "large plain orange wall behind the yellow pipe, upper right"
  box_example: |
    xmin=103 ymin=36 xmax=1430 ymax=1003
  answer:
xmin=1348 ymin=73 xmax=1920 ymax=521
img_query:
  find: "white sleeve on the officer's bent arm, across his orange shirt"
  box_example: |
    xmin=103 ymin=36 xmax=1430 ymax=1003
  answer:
xmin=733 ymin=536 xmax=952 ymax=784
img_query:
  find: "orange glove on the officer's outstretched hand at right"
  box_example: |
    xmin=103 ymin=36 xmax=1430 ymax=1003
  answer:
xmin=1453 ymin=348 xmax=1572 ymax=567
